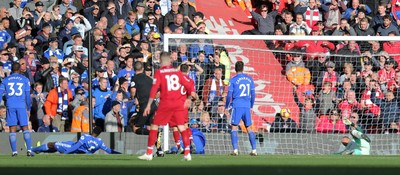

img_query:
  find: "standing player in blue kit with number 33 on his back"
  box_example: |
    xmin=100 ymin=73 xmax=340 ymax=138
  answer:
xmin=0 ymin=63 xmax=33 ymax=157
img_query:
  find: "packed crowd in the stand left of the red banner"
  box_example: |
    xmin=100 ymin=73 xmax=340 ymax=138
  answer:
xmin=0 ymin=0 xmax=234 ymax=132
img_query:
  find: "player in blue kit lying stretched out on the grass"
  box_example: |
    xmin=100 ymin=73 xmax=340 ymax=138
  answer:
xmin=32 ymin=127 xmax=121 ymax=154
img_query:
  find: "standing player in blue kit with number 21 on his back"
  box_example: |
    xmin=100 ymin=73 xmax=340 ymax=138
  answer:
xmin=225 ymin=61 xmax=257 ymax=156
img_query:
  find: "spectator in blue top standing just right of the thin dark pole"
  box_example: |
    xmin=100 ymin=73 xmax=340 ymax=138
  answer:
xmin=93 ymin=76 xmax=112 ymax=129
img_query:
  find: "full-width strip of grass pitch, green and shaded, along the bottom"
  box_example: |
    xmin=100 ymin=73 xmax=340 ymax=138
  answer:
xmin=0 ymin=154 xmax=400 ymax=175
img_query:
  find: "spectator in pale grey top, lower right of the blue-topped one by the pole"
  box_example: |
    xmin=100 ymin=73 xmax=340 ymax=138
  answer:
xmin=105 ymin=101 xmax=124 ymax=132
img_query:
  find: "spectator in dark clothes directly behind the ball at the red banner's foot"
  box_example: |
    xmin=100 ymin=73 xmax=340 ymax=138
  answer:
xmin=270 ymin=109 xmax=297 ymax=133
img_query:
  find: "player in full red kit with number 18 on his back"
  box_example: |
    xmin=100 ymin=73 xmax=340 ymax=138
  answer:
xmin=138 ymin=53 xmax=196 ymax=161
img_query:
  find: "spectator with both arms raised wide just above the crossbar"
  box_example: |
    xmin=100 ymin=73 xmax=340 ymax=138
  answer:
xmin=242 ymin=5 xmax=279 ymax=35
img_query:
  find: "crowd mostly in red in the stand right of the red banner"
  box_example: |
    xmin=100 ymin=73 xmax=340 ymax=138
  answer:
xmin=243 ymin=0 xmax=400 ymax=133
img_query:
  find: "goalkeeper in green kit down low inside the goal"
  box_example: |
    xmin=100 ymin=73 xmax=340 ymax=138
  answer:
xmin=337 ymin=114 xmax=371 ymax=155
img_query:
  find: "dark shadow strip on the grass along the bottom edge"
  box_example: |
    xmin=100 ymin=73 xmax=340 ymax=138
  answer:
xmin=0 ymin=165 xmax=400 ymax=175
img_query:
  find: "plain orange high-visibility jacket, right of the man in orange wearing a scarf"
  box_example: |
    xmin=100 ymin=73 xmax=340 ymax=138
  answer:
xmin=71 ymin=106 xmax=89 ymax=132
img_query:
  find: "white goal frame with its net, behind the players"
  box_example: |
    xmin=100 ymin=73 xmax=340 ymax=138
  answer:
xmin=152 ymin=35 xmax=400 ymax=154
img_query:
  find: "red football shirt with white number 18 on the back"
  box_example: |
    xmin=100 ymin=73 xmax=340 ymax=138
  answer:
xmin=150 ymin=66 xmax=194 ymax=110
